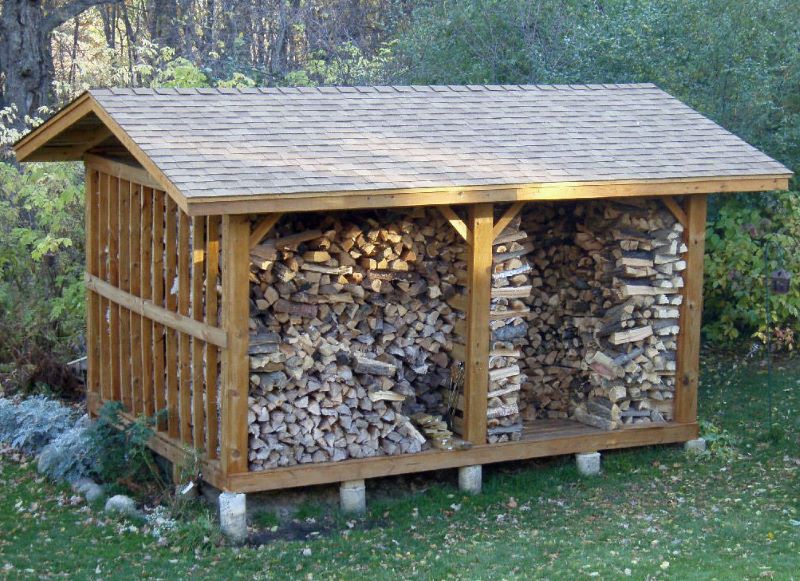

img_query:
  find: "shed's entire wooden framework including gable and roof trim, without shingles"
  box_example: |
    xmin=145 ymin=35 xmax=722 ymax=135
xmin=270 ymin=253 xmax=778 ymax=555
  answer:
xmin=15 ymin=82 xmax=790 ymax=492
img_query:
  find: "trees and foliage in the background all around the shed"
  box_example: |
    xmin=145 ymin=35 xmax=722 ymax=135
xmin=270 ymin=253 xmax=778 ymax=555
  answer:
xmin=0 ymin=0 xmax=800 ymax=390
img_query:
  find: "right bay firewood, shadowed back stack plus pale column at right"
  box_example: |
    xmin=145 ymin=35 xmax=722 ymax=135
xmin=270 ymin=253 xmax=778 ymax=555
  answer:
xmin=523 ymin=201 xmax=686 ymax=429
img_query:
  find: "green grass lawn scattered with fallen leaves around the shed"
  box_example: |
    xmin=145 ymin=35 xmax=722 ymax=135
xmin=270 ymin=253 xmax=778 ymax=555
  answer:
xmin=0 ymin=355 xmax=800 ymax=580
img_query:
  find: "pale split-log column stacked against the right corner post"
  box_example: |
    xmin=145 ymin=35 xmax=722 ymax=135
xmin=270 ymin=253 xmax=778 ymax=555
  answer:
xmin=575 ymin=201 xmax=686 ymax=429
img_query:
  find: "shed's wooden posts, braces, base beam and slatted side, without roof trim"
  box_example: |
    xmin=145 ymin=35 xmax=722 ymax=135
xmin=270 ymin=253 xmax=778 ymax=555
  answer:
xmin=73 ymin=162 xmax=768 ymax=492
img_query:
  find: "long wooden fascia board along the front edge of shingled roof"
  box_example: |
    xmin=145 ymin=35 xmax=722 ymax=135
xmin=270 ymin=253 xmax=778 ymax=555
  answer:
xmin=186 ymin=175 xmax=789 ymax=216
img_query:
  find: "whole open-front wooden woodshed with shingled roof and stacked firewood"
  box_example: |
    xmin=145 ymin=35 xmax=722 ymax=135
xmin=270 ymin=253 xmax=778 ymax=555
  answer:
xmin=15 ymin=84 xmax=791 ymax=492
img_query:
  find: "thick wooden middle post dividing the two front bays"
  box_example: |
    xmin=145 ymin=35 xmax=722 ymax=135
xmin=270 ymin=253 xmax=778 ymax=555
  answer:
xmin=463 ymin=204 xmax=494 ymax=444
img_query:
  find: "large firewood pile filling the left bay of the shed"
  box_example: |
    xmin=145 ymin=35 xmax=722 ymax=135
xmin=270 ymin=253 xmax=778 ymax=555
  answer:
xmin=249 ymin=210 xmax=465 ymax=470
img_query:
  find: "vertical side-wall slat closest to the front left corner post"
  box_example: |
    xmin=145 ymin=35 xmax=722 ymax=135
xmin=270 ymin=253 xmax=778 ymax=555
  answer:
xmin=206 ymin=216 xmax=220 ymax=459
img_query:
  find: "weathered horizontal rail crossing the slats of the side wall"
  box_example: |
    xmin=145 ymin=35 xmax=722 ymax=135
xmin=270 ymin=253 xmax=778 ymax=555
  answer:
xmin=86 ymin=273 xmax=228 ymax=349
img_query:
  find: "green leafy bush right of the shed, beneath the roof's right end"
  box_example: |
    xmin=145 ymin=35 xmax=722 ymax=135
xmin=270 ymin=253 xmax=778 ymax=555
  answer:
xmin=704 ymin=192 xmax=800 ymax=345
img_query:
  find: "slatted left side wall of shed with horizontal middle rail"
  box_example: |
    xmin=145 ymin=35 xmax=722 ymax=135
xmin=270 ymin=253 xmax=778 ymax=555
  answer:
xmin=86 ymin=165 xmax=226 ymax=459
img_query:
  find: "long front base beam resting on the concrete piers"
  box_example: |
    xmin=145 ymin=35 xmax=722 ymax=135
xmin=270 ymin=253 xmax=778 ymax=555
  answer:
xmin=225 ymin=424 xmax=698 ymax=492
